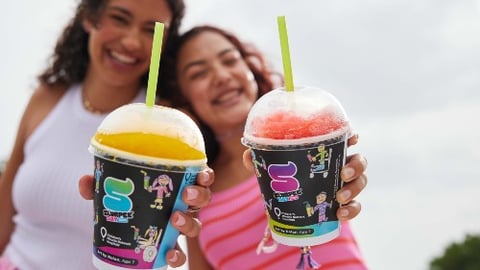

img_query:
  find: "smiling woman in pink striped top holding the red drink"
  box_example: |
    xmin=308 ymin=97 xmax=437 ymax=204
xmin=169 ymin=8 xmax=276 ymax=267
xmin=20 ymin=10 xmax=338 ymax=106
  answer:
xmin=163 ymin=26 xmax=366 ymax=270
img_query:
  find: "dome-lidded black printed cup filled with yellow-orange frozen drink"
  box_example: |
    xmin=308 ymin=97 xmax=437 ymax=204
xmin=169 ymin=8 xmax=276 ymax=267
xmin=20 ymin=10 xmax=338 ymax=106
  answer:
xmin=89 ymin=103 xmax=206 ymax=269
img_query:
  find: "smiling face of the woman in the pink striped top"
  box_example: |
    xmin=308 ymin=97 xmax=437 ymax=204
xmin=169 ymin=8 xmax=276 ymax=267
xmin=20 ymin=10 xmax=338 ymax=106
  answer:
xmin=177 ymin=29 xmax=259 ymax=136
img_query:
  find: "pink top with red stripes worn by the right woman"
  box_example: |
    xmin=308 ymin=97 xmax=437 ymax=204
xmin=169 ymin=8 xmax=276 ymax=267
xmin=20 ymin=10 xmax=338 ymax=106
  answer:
xmin=199 ymin=177 xmax=367 ymax=270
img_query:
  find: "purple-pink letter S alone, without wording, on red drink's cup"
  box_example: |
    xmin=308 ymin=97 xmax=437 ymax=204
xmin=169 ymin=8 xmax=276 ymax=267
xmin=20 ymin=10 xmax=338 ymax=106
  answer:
xmin=268 ymin=161 xmax=300 ymax=193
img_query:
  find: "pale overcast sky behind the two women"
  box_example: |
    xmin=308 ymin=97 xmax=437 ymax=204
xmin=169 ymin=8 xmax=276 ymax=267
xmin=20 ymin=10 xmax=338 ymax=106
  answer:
xmin=0 ymin=0 xmax=480 ymax=270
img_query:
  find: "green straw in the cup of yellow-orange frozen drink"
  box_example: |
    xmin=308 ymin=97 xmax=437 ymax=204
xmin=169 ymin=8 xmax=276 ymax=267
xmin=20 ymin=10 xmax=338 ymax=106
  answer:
xmin=145 ymin=22 xmax=164 ymax=107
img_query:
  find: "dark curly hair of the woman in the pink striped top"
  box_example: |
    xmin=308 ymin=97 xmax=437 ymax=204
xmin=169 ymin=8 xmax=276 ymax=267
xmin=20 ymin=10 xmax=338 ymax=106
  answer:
xmin=163 ymin=25 xmax=283 ymax=165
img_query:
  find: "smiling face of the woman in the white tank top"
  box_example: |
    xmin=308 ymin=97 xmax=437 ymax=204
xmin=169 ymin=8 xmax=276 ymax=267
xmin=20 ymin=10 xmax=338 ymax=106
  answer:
xmin=82 ymin=1 xmax=172 ymax=94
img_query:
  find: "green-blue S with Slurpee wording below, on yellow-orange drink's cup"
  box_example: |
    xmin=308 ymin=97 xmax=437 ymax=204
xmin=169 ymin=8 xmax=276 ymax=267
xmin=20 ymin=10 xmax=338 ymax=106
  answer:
xmin=103 ymin=176 xmax=135 ymax=223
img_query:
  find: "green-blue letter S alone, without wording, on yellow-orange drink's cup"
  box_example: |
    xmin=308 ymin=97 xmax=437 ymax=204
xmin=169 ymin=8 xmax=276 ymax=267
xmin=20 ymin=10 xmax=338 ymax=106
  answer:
xmin=103 ymin=176 xmax=135 ymax=212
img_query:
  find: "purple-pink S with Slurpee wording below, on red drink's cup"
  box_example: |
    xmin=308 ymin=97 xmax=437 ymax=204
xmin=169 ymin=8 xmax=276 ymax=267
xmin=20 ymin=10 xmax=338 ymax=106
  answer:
xmin=267 ymin=161 xmax=302 ymax=202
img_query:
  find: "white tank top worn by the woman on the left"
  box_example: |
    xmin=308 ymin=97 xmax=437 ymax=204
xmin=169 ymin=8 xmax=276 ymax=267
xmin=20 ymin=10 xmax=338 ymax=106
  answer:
xmin=5 ymin=85 xmax=145 ymax=270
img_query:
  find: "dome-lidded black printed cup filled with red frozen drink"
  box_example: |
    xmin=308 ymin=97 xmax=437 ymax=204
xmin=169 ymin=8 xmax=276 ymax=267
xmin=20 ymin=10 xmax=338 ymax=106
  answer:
xmin=242 ymin=87 xmax=350 ymax=247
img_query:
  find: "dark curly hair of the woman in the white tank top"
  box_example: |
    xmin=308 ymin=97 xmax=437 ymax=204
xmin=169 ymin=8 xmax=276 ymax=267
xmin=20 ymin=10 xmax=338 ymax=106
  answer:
xmin=38 ymin=0 xmax=185 ymax=98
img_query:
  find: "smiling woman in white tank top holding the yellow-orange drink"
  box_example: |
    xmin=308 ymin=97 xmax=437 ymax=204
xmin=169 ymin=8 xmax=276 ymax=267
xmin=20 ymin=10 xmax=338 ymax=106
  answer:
xmin=0 ymin=0 xmax=214 ymax=270
